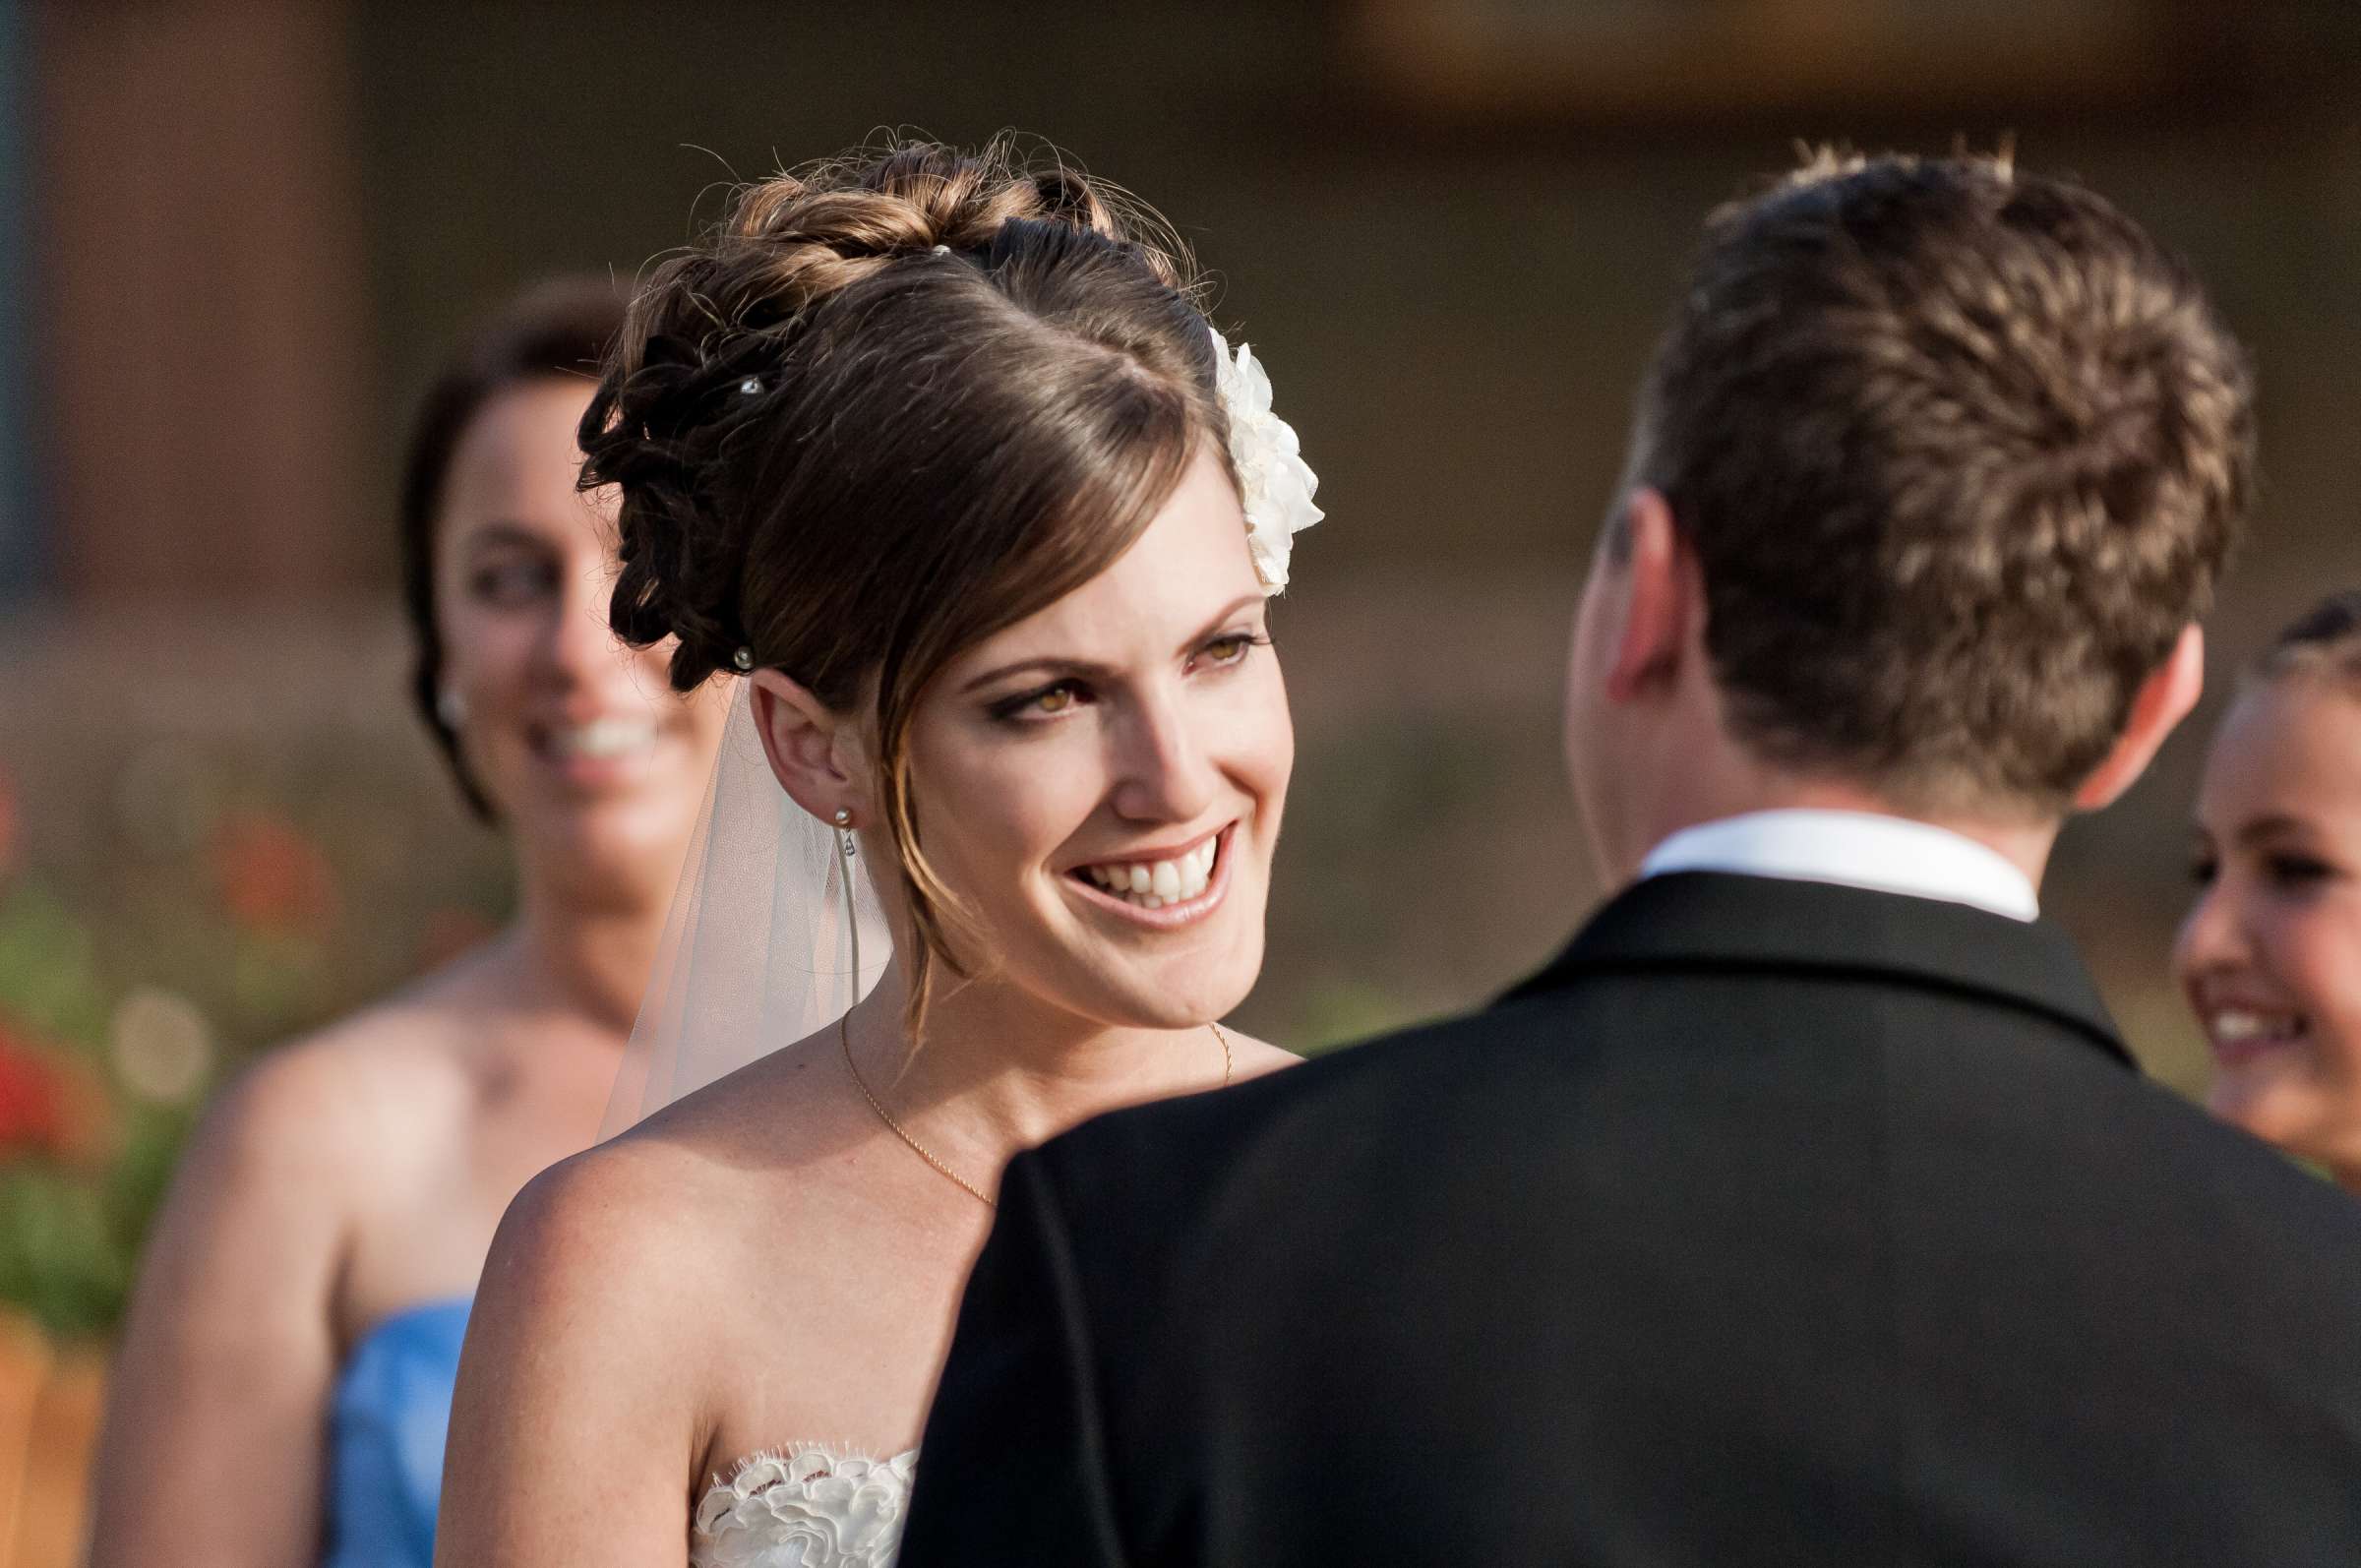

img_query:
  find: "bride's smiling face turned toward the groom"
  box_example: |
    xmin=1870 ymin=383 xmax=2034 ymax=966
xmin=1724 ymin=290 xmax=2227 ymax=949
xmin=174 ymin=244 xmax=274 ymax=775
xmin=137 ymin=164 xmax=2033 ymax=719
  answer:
xmin=909 ymin=441 xmax=1294 ymax=1027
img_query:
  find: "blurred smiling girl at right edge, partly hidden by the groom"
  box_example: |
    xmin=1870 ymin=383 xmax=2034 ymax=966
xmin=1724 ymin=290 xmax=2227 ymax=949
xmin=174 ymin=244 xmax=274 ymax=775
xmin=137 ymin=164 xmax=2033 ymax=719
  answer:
xmin=2174 ymin=593 xmax=2361 ymax=1192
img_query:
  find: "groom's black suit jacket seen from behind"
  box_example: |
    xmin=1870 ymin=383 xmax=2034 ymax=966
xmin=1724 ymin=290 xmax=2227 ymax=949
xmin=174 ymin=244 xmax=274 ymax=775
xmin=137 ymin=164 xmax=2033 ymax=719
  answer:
xmin=902 ymin=874 xmax=2361 ymax=1568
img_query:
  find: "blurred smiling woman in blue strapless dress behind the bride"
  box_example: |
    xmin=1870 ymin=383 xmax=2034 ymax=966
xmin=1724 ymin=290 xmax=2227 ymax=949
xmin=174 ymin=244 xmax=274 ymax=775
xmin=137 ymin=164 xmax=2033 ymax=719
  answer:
xmin=94 ymin=281 xmax=725 ymax=1568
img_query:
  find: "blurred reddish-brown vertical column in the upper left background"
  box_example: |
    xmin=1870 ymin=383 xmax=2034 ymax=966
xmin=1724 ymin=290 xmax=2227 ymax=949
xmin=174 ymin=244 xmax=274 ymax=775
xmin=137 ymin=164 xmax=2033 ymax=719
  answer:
xmin=29 ymin=0 xmax=378 ymax=602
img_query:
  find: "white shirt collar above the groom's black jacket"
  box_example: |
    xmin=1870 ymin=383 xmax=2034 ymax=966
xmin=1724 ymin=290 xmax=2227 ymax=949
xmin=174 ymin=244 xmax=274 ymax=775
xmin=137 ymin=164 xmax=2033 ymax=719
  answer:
xmin=1639 ymin=810 xmax=2040 ymax=921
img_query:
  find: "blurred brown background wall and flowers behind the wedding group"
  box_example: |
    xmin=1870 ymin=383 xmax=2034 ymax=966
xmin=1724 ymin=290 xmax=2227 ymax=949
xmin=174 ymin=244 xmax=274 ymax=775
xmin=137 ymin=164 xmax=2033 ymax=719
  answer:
xmin=0 ymin=0 xmax=2361 ymax=1568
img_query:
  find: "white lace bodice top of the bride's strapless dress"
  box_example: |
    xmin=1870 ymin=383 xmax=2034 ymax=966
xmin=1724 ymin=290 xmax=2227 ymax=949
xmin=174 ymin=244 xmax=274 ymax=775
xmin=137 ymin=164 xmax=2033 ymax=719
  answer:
xmin=690 ymin=1443 xmax=919 ymax=1568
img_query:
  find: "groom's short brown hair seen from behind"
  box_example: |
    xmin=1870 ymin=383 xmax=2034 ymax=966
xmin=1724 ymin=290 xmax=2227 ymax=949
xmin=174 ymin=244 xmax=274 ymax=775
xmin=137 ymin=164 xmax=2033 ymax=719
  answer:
xmin=1631 ymin=155 xmax=2255 ymax=813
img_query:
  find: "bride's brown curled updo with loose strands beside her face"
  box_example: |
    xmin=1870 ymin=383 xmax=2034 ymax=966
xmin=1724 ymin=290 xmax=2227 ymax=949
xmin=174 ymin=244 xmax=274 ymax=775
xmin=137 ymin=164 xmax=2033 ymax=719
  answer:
xmin=580 ymin=137 xmax=1228 ymax=1025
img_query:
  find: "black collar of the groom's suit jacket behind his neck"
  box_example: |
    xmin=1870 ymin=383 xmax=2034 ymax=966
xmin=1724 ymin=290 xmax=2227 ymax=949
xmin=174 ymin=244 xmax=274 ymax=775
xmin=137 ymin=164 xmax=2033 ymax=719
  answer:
xmin=1501 ymin=872 xmax=2132 ymax=1067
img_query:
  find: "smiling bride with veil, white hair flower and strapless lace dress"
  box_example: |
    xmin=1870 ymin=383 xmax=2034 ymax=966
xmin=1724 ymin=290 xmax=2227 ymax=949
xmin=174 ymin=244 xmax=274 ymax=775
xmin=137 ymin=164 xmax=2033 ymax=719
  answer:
xmin=437 ymin=144 xmax=1320 ymax=1568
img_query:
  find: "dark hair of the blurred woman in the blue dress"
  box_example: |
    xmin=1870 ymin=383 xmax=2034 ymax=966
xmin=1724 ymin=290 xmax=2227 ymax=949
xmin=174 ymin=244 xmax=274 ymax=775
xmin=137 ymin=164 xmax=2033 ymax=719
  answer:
xmin=399 ymin=276 xmax=624 ymax=821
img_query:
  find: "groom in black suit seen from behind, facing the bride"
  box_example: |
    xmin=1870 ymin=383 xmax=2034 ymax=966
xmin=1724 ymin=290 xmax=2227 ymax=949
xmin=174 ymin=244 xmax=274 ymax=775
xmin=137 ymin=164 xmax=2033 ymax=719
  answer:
xmin=904 ymin=158 xmax=2361 ymax=1568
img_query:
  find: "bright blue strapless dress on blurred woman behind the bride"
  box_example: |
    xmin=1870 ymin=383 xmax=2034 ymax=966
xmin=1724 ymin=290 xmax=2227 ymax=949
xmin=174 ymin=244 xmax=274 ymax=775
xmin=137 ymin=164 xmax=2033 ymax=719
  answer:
xmin=324 ymin=1298 xmax=472 ymax=1568
